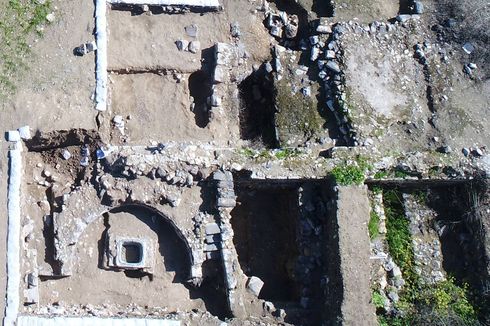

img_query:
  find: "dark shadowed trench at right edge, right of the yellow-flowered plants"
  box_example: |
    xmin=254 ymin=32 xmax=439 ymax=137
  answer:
xmin=376 ymin=177 xmax=490 ymax=322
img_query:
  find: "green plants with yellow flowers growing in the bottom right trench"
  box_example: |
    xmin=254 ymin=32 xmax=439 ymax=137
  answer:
xmin=373 ymin=190 xmax=479 ymax=326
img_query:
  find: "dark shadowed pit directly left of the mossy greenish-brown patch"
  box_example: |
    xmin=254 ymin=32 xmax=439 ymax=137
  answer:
xmin=239 ymin=69 xmax=278 ymax=148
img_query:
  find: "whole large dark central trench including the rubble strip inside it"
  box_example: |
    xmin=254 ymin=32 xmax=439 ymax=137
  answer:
xmin=231 ymin=181 xmax=338 ymax=325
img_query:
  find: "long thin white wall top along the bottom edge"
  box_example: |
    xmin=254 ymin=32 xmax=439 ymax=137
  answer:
xmin=17 ymin=316 xmax=180 ymax=326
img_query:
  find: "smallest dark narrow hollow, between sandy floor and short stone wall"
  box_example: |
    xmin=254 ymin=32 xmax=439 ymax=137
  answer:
xmin=189 ymin=70 xmax=213 ymax=128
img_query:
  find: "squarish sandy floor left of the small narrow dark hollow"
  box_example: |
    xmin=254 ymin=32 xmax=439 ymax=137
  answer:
xmin=111 ymin=73 xmax=226 ymax=144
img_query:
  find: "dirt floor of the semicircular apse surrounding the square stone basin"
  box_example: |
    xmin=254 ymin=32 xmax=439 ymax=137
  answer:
xmin=40 ymin=208 xmax=224 ymax=315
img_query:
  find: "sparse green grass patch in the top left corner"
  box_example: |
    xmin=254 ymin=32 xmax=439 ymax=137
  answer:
xmin=0 ymin=0 xmax=51 ymax=99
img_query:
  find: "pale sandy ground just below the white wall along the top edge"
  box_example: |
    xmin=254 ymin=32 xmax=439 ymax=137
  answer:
xmin=108 ymin=1 xmax=270 ymax=72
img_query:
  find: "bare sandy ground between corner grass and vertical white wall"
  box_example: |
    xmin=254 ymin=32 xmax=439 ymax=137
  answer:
xmin=0 ymin=0 xmax=97 ymax=134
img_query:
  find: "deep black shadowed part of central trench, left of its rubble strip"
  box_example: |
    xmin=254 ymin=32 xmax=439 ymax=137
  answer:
xmin=231 ymin=183 xmax=299 ymax=302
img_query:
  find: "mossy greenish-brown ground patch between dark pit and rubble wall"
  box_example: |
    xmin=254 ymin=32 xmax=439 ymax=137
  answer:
xmin=276 ymin=79 xmax=325 ymax=145
